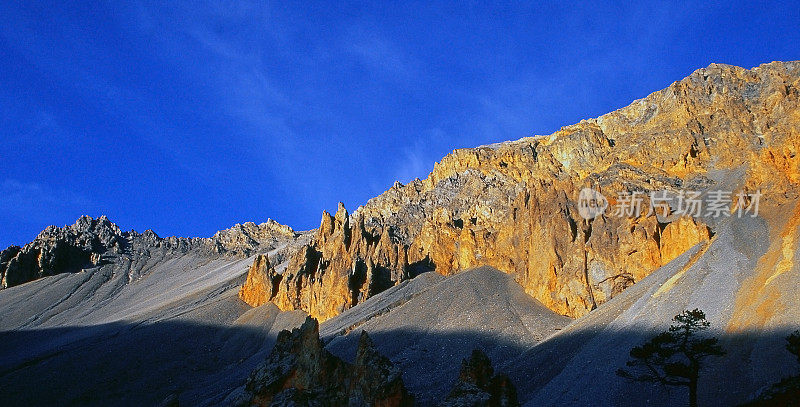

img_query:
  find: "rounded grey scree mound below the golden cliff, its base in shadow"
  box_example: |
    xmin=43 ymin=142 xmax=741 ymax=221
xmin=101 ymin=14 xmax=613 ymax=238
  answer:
xmin=321 ymin=267 xmax=571 ymax=405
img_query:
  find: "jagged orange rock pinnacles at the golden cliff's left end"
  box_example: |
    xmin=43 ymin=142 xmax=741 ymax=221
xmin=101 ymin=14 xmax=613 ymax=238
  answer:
xmin=240 ymin=203 xmax=418 ymax=320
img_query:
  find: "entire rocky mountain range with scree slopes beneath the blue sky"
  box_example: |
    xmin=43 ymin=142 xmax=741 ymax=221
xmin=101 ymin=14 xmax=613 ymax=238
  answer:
xmin=0 ymin=62 xmax=800 ymax=406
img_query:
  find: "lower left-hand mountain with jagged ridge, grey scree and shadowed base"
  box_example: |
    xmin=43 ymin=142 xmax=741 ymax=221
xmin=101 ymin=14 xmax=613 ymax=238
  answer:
xmin=0 ymin=217 xmax=305 ymax=405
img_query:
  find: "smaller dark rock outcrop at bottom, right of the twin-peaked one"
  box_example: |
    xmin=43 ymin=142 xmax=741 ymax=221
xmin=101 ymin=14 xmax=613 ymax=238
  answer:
xmin=439 ymin=349 xmax=519 ymax=407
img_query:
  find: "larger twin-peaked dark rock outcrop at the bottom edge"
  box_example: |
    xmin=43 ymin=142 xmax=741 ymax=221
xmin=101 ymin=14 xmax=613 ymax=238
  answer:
xmin=235 ymin=317 xmax=414 ymax=407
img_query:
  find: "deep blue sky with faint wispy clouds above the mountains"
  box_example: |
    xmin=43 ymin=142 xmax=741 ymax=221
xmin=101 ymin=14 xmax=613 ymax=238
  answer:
xmin=0 ymin=1 xmax=800 ymax=247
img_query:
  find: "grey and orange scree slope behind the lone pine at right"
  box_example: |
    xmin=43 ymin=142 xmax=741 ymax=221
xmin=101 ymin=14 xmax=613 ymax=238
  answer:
xmin=499 ymin=204 xmax=800 ymax=407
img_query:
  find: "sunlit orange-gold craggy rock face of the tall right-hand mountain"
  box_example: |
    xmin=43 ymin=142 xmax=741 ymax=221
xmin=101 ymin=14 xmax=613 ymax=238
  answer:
xmin=243 ymin=62 xmax=800 ymax=320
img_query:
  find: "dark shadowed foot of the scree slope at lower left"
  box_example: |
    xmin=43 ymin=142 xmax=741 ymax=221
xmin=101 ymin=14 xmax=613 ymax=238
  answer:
xmin=0 ymin=306 xmax=305 ymax=406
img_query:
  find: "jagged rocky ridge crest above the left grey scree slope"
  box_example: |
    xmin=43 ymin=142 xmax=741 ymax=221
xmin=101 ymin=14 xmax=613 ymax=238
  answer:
xmin=0 ymin=216 xmax=299 ymax=288
